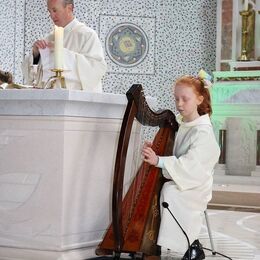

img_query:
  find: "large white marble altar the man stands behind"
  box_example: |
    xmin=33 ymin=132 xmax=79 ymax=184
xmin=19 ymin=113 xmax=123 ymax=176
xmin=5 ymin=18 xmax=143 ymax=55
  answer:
xmin=0 ymin=89 xmax=148 ymax=260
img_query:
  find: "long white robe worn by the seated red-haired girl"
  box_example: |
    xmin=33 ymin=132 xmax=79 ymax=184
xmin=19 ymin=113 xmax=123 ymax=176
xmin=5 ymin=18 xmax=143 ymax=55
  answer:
xmin=157 ymin=115 xmax=220 ymax=254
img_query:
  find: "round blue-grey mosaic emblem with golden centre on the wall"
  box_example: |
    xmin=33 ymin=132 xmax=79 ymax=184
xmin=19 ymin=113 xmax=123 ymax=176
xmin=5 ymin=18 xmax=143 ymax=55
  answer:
xmin=106 ymin=23 xmax=148 ymax=67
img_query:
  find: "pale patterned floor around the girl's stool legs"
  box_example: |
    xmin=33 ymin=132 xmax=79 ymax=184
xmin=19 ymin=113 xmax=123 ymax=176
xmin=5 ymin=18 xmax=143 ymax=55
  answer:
xmin=163 ymin=210 xmax=260 ymax=260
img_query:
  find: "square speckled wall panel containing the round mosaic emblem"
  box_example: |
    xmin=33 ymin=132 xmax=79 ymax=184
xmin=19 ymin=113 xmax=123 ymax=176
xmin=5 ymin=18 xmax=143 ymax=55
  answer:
xmin=100 ymin=15 xmax=155 ymax=74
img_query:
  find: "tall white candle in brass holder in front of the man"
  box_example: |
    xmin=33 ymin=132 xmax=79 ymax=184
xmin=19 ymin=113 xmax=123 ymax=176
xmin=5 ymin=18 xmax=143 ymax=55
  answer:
xmin=54 ymin=26 xmax=64 ymax=69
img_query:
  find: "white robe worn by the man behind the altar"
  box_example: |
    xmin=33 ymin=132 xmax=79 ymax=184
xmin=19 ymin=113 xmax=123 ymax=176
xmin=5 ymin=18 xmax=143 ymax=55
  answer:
xmin=22 ymin=19 xmax=107 ymax=92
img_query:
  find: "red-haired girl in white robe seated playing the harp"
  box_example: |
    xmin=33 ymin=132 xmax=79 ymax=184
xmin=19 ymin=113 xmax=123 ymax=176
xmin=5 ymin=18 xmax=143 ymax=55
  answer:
xmin=142 ymin=71 xmax=220 ymax=260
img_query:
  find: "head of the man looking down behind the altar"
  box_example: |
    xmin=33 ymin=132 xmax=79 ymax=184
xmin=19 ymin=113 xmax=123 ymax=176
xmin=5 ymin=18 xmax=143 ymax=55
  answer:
xmin=47 ymin=0 xmax=73 ymax=27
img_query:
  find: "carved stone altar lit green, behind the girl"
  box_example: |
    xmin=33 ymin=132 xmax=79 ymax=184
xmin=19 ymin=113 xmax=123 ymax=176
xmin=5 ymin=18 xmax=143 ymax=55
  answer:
xmin=211 ymin=71 xmax=260 ymax=179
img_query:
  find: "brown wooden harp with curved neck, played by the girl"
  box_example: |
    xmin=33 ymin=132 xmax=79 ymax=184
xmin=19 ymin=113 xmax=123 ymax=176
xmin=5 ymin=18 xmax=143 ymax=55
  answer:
xmin=96 ymin=84 xmax=178 ymax=259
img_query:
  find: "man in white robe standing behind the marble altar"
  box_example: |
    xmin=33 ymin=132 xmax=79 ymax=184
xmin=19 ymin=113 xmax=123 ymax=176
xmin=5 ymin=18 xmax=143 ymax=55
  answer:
xmin=22 ymin=0 xmax=107 ymax=92
